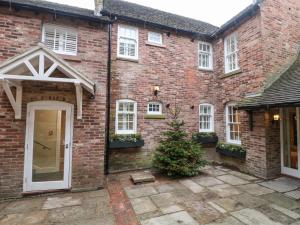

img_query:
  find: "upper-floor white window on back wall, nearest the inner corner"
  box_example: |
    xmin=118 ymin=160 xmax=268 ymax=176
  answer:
xmin=198 ymin=42 xmax=213 ymax=70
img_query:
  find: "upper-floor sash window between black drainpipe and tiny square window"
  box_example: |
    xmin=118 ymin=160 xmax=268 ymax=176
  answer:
xmin=118 ymin=25 xmax=139 ymax=59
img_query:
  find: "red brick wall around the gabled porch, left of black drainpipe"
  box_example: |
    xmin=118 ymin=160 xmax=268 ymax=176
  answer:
xmin=0 ymin=8 xmax=108 ymax=197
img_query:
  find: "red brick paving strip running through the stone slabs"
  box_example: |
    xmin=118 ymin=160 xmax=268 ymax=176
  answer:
xmin=107 ymin=176 xmax=139 ymax=225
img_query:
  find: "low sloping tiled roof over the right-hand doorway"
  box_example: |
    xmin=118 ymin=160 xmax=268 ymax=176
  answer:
xmin=238 ymin=53 xmax=300 ymax=111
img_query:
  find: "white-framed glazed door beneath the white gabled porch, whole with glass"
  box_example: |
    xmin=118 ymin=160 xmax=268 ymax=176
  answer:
xmin=23 ymin=101 xmax=73 ymax=192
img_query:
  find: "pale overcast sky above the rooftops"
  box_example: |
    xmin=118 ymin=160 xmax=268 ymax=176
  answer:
xmin=48 ymin=0 xmax=253 ymax=26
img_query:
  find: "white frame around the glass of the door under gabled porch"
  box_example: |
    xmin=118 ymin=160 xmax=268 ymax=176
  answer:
xmin=23 ymin=101 xmax=74 ymax=192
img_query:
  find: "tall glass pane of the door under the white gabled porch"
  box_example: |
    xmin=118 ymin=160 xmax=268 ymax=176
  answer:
xmin=32 ymin=110 xmax=66 ymax=182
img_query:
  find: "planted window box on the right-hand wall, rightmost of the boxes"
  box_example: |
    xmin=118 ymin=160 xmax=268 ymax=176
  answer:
xmin=216 ymin=143 xmax=246 ymax=160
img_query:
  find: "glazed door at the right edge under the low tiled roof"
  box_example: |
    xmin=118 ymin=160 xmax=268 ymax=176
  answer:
xmin=280 ymin=107 xmax=300 ymax=178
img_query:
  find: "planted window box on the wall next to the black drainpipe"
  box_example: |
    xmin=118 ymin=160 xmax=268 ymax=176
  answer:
xmin=109 ymin=134 xmax=145 ymax=149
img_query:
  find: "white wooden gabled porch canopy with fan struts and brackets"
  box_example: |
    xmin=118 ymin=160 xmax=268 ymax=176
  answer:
xmin=0 ymin=43 xmax=95 ymax=119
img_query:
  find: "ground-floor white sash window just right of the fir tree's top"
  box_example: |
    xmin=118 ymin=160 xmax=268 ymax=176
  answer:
xmin=199 ymin=104 xmax=214 ymax=132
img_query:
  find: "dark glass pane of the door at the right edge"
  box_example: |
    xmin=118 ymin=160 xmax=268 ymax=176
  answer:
xmin=283 ymin=108 xmax=298 ymax=170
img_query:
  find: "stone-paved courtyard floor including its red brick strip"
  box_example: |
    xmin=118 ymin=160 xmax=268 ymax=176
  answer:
xmin=0 ymin=166 xmax=300 ymax=225
